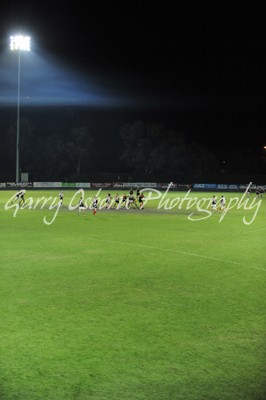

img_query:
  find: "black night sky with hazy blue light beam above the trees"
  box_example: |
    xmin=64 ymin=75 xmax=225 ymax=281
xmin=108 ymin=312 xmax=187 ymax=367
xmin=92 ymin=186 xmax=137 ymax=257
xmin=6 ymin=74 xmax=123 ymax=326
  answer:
xmin=0 ymin=0 xmax=266 ymax=168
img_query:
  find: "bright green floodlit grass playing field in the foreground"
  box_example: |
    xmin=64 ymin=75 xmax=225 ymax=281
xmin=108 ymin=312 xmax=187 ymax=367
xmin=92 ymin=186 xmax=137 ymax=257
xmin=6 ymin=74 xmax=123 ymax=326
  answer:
xmin=0 ymin=190 xmax=266 ymax=400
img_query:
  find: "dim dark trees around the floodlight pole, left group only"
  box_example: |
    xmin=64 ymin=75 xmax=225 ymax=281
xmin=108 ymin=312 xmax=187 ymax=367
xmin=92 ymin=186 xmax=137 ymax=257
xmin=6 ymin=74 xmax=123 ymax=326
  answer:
xmin=0 ymin=119 xmax=93 ymax=180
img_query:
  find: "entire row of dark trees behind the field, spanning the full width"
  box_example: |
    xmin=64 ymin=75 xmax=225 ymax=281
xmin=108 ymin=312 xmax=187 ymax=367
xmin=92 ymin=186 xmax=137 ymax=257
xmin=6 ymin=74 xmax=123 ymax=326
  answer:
xmin=0 ymin=119 xmax=266 ymax=181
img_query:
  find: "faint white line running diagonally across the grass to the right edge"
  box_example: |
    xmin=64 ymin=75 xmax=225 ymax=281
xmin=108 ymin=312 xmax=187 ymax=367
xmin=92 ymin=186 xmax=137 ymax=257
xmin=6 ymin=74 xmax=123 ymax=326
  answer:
xmin=90 ymin=238 xmax=266 ymax=272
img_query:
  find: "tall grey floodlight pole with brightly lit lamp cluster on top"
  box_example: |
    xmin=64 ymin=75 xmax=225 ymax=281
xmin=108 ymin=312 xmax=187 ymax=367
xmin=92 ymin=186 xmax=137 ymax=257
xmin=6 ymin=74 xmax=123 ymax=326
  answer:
xmin=10 ymin=35 xmax=30 ymax=183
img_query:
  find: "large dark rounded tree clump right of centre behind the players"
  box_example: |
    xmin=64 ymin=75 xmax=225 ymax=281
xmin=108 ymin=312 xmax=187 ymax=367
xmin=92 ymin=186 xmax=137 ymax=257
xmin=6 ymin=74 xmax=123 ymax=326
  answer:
xmin=120 ymin=121 xmax=218 ymax=176
